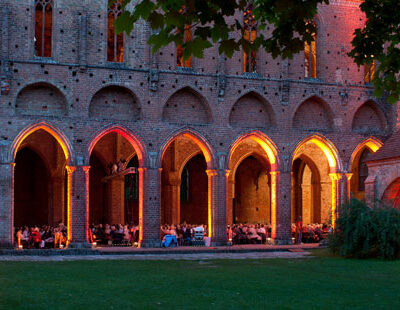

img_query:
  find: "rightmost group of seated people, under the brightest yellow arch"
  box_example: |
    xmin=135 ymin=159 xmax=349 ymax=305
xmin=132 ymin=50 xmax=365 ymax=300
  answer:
xmin=292 ymin=223 xmax=332 ymax=243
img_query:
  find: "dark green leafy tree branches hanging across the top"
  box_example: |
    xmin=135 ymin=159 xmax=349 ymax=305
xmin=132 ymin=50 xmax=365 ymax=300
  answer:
xmin=110 ymin=0 xmax=400 ymax=103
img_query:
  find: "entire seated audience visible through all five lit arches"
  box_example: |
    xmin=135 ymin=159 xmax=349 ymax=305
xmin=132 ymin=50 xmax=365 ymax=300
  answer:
xmin=15 ymin=223 xmax=331 ymax=249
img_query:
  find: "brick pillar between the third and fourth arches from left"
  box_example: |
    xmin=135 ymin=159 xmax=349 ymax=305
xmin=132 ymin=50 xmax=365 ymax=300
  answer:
xmin=206 ymin=169 xmax=230 ymax=246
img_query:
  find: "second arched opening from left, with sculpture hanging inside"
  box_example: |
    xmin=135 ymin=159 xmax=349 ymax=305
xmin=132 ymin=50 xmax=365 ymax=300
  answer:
xmin=89 ymin=130 xmax=141 ymax=225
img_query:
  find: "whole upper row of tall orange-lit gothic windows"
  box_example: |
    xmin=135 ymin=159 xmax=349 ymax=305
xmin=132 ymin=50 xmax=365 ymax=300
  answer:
xmin=34 ymin=0 xmax=375 ymax=83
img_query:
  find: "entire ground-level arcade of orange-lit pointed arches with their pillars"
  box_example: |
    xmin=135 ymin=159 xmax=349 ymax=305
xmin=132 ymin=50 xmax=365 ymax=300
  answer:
xmin=0 ymin=127 xmax=388 ymax=246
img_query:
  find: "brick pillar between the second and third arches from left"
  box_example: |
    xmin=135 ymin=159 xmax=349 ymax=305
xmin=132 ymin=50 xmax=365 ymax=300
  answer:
xmin=138 ymin=168 xmax=161 ymax=248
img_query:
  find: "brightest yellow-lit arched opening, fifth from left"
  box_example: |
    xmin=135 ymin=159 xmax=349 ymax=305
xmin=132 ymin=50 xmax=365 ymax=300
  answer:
xmin=291 ymin=135 xmax=341 ymax=226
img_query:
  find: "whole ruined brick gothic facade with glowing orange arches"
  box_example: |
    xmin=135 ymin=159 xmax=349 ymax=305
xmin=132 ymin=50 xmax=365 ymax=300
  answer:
xmin=0 ymin=0 xmax=397 ymax=247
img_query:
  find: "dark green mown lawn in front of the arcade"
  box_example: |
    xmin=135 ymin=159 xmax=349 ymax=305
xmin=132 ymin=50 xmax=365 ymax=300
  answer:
xmin=0 ymin=250 xmax=400 ymax=310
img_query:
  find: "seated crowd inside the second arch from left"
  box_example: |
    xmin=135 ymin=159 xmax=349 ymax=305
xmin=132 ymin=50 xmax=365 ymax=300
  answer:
xmin=89 ymin=224 xmax=139 ymax=246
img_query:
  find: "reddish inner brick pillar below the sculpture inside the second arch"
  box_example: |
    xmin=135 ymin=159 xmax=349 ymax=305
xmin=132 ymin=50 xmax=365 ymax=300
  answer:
xmin=108 ymin=176 xmax=125 ymax=225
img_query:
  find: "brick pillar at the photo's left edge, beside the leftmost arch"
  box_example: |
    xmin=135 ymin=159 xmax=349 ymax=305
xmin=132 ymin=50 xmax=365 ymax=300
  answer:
xmin=0 ymin=158 xmax=15 ymax=248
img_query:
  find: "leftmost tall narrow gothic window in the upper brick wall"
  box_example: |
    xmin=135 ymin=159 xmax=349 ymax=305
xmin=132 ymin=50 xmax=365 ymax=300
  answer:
xmin=34 ymin=0 xmax=53 ymax=57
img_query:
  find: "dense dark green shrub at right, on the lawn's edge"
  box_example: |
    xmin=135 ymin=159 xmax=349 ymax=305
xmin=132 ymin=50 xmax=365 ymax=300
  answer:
xmin=329 ymin=199 xmax=400 ymax=259
